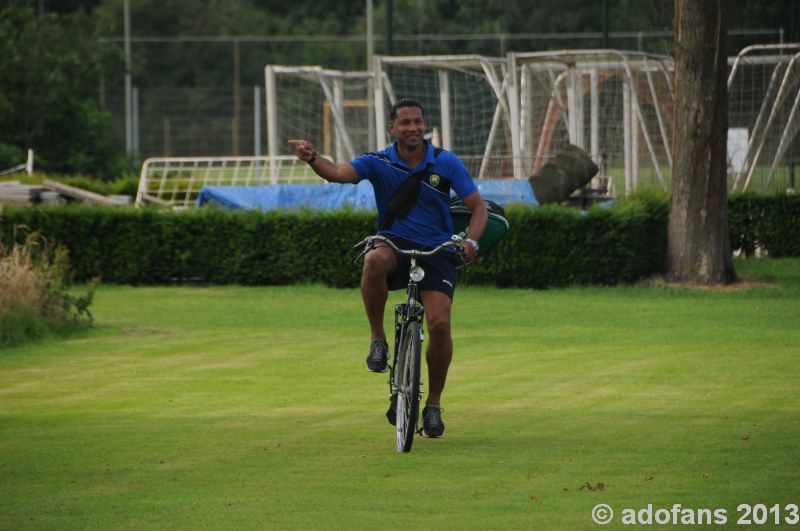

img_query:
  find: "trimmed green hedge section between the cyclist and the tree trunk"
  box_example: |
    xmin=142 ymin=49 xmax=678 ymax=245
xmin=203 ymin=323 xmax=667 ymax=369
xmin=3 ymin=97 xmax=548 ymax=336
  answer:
xmin=464 ymin=201 xmax=667 ymax=288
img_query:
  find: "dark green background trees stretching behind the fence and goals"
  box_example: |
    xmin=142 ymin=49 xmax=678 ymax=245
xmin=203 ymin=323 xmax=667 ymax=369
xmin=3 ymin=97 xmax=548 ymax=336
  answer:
xmin=0 ymin=0 xmax=800 ymax=179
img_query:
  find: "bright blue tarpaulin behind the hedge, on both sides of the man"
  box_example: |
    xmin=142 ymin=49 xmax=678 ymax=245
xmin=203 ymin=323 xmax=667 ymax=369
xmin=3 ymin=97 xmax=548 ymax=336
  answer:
xmin=196 ymin=179 xmax=538 ymax=211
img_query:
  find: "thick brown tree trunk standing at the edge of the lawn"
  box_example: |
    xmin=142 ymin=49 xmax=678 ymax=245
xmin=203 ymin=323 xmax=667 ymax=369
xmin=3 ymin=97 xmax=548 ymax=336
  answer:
xmin=666 ymin=0 xmax=736 ymax=285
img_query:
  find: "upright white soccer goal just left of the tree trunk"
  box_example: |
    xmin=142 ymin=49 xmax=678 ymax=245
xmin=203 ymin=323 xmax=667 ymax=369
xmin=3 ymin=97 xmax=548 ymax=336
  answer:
xmin=510 ymin=50 xmax=674 ymax=193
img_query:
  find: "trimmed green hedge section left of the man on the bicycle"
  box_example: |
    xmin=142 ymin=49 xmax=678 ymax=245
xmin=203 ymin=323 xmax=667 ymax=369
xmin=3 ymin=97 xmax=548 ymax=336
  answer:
xmin=2 ymin=205 xmax=374 ymax=285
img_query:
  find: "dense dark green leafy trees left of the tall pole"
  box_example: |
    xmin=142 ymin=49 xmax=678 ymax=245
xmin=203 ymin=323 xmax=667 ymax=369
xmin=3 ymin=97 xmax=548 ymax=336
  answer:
xmin=0 ymin=0 xmax=124 ymax=177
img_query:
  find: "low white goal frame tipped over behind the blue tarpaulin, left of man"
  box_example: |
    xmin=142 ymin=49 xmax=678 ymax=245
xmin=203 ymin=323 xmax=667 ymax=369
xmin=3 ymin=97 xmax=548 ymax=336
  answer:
xmin=136 ymin=155 xmax=320 ymax=208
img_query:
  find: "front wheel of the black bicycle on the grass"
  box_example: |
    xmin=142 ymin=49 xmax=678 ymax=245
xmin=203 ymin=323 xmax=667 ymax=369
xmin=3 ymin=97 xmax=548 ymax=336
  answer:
xmin=395 ymin=321 xmax=422 ymax=452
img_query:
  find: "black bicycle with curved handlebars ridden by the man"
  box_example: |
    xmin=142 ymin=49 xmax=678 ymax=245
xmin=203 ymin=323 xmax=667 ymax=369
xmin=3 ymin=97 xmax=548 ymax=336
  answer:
xmin=354 ymin=235 xmax=463 ymax=452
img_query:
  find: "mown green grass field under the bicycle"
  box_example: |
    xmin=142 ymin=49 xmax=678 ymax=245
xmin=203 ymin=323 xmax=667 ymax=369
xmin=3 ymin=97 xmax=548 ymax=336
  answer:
xmin=0 ymin=259 xmax=800 ymax=530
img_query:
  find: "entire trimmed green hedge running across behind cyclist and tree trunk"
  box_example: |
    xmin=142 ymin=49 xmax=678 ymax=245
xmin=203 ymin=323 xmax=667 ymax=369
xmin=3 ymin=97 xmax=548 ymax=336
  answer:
xmin=0 ymin=195 xmax=800 ymax=288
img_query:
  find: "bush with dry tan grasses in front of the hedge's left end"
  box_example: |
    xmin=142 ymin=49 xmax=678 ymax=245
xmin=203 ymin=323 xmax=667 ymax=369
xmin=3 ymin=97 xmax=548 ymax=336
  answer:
xmin=0 ymin=228 xmax=95 ymax=348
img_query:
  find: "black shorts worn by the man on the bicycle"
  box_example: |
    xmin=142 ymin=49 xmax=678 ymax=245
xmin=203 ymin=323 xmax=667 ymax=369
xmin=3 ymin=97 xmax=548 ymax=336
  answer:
xmin=387 ymin=236 xmax=459 ymax=300
